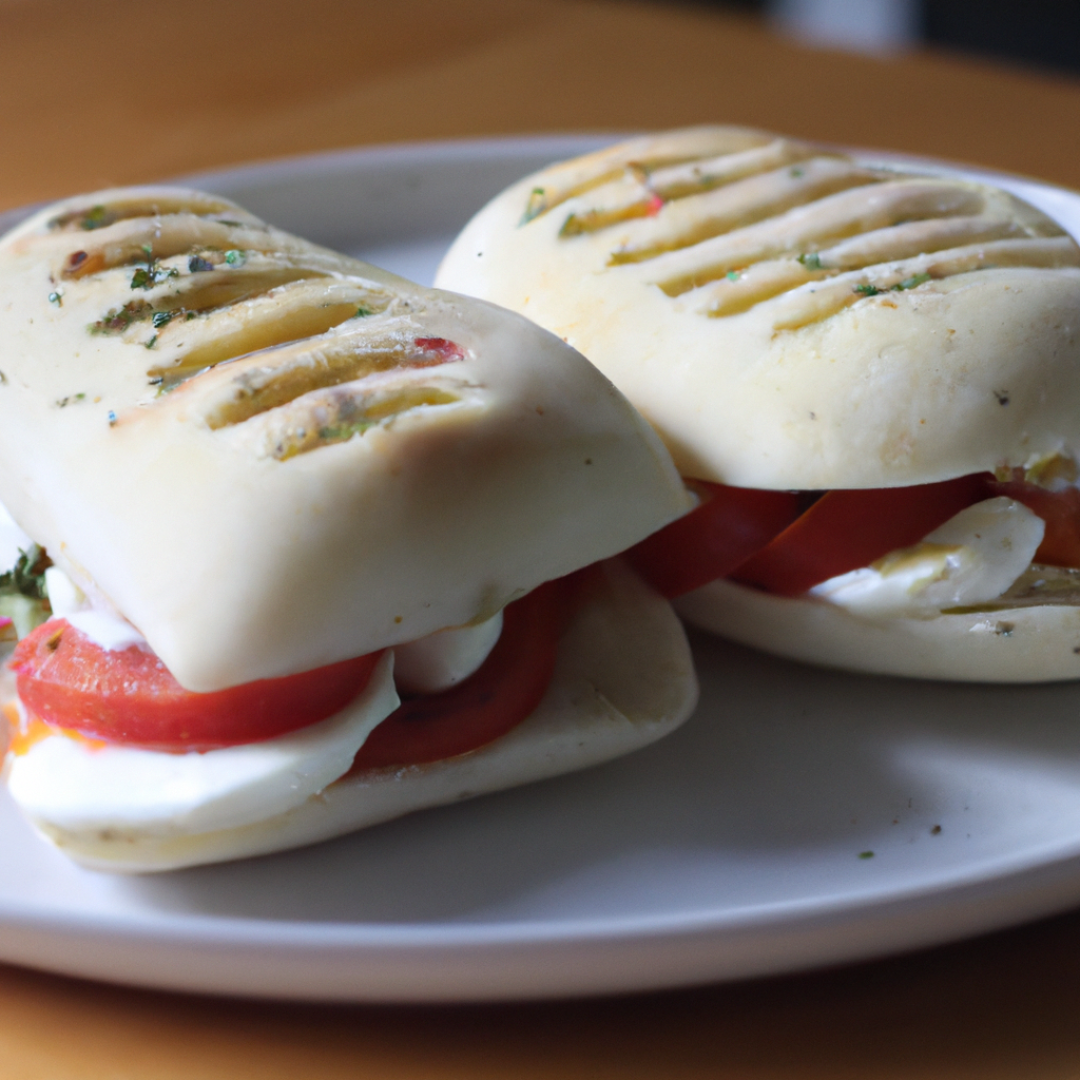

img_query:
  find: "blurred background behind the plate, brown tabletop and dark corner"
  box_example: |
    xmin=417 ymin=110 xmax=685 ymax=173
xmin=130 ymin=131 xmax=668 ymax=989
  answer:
xmin=0 ymin=0 xmax=1080 ymax=211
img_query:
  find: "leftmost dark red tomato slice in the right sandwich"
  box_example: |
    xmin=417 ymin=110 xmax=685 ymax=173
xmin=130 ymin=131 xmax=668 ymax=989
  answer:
xmin=626 ymin=481 xmax=800 ymax=599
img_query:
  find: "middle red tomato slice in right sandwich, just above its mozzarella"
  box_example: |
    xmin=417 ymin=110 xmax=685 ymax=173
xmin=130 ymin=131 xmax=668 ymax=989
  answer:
xmin=731 ymin=473 xmax=987 ymax=596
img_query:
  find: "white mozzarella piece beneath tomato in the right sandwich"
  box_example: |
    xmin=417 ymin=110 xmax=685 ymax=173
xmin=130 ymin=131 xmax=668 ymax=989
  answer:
xmin=810 ymin=497 xmax=1045 ymax=618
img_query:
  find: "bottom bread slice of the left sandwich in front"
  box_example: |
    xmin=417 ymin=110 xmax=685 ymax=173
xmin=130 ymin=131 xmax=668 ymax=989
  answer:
xmin=23 ymin=561 xmax=698 ymax=873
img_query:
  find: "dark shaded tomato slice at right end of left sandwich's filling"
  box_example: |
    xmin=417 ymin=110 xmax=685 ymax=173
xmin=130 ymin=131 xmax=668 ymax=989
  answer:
xmin=347 ymin=578 xmax=569 ymax=774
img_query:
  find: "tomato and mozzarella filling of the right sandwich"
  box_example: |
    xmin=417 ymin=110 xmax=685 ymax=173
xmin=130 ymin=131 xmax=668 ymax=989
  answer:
xmin=631 ymin=458 xmax=1080 ymax=618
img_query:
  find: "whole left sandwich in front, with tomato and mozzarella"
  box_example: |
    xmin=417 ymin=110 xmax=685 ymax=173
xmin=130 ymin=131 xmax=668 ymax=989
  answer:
xmin=0 ymin=188 xmax=697 ymax=872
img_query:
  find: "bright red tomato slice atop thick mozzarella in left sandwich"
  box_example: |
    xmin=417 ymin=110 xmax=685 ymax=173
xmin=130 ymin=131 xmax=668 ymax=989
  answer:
xmin=11 ymin=619 xmax=380 ymax=751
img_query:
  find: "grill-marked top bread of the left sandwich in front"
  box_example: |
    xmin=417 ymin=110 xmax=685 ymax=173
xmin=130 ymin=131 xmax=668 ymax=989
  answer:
xmin=0 ymin=188 xmax=687 ymax=691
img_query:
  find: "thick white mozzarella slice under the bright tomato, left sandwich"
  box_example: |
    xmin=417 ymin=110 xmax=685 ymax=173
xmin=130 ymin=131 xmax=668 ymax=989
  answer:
xmin=8 ymin=652 xmax=399 ymax=838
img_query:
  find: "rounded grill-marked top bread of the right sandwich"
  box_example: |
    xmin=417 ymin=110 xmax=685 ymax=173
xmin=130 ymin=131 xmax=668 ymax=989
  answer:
xmin=436 ymin=127 xmax=1080 ymax=490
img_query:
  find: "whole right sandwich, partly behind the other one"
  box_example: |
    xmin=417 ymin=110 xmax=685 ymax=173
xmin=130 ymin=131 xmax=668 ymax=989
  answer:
xmin=436 ymin=126 xmax=1080 ymax=681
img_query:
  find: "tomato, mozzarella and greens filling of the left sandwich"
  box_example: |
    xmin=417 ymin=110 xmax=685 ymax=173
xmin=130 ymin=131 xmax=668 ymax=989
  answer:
xmin=0 ymin=515 xmax=575 ymax=835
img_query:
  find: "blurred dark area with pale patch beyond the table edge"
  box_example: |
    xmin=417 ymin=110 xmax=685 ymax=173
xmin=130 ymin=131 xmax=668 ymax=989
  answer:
xmin=704 ymin=0 xmax=1080 ymax=72
